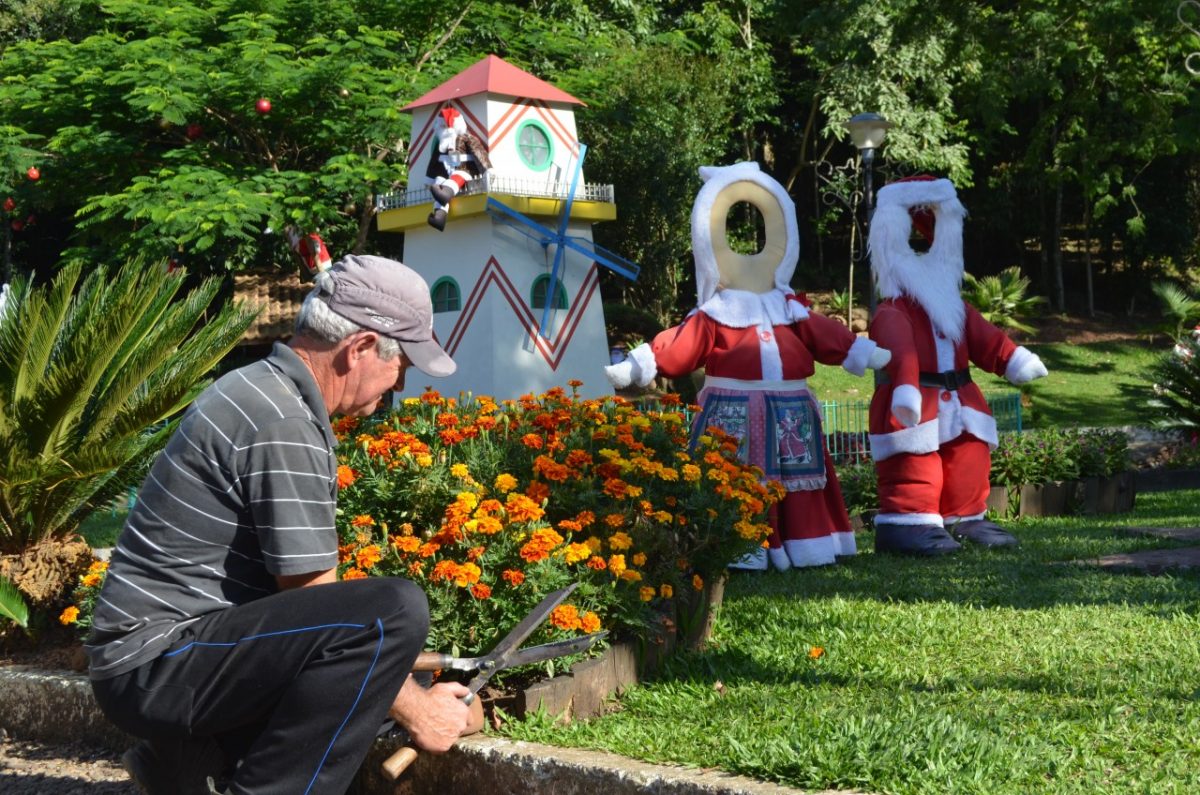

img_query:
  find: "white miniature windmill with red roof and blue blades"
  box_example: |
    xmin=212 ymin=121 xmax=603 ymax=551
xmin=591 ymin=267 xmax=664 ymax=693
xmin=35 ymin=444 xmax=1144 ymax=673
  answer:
xmin=377 ymin=55 xmax=638 ymax=399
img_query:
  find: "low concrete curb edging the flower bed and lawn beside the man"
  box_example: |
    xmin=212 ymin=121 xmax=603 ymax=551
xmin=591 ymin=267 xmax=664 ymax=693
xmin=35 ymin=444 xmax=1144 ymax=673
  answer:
xmin=0 ymin=665 xmax=835 ymax=795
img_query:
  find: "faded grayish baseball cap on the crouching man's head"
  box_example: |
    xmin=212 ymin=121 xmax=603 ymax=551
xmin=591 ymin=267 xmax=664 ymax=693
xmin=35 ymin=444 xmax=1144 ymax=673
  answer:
xmin=318 ymin=255 xmax=458 ymax=376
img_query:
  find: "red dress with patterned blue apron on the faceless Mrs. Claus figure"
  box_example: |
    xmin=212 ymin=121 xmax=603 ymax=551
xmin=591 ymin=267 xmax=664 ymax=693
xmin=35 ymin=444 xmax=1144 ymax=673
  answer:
xmin=650 ymin=291 xmax=875 ymax=569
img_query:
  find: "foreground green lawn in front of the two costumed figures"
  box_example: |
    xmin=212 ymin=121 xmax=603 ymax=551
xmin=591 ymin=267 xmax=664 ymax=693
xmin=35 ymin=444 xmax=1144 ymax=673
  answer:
xmin=504 ymin=489 xmax=1200 ymax=795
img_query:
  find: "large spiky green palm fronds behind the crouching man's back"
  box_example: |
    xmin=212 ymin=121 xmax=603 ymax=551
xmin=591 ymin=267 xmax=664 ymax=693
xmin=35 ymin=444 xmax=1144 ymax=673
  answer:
xmin=0 ymin=262 xmax=254 ymax=552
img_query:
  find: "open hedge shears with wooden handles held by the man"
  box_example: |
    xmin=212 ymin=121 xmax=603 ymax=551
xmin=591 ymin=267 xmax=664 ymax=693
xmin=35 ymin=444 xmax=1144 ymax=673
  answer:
xmin=383 ymin=582 xmax=608 ymax=781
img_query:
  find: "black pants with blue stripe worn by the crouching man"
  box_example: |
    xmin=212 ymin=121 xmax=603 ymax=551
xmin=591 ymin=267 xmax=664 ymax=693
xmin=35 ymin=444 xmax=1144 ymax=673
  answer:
xmin=92 ymin=578 xmax=430 ymax=795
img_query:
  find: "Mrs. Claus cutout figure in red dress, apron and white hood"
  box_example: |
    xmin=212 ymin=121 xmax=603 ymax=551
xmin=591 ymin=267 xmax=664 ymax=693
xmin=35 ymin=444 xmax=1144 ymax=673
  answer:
xmin=606 ymin=162 xmax=888 ymax=569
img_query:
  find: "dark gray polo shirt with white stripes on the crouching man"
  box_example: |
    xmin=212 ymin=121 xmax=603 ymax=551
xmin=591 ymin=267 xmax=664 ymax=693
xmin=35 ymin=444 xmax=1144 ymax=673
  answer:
xmin=86 ymin=343 xmax=337 ymax=680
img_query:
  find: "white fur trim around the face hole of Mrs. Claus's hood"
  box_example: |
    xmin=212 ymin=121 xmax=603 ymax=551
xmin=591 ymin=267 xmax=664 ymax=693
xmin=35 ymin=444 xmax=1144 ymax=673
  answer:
xmin=691 ymin=161 xmax=800 ymax=306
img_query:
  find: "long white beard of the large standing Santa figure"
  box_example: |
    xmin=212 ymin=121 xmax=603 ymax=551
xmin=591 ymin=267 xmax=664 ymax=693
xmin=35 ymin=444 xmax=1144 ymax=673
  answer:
xmin=868 ymin=197 xmax=966 ymax=343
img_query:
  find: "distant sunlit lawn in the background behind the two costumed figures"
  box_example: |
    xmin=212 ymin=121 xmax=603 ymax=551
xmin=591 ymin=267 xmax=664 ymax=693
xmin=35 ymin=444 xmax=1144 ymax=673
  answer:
xmin=809 ymin=340 xmax=1169 ymax=428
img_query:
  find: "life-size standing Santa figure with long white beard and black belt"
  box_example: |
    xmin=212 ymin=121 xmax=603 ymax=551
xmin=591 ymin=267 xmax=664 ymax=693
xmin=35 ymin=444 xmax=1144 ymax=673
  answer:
xmin=869 ymin=177 xmax=1046 ymax=555
